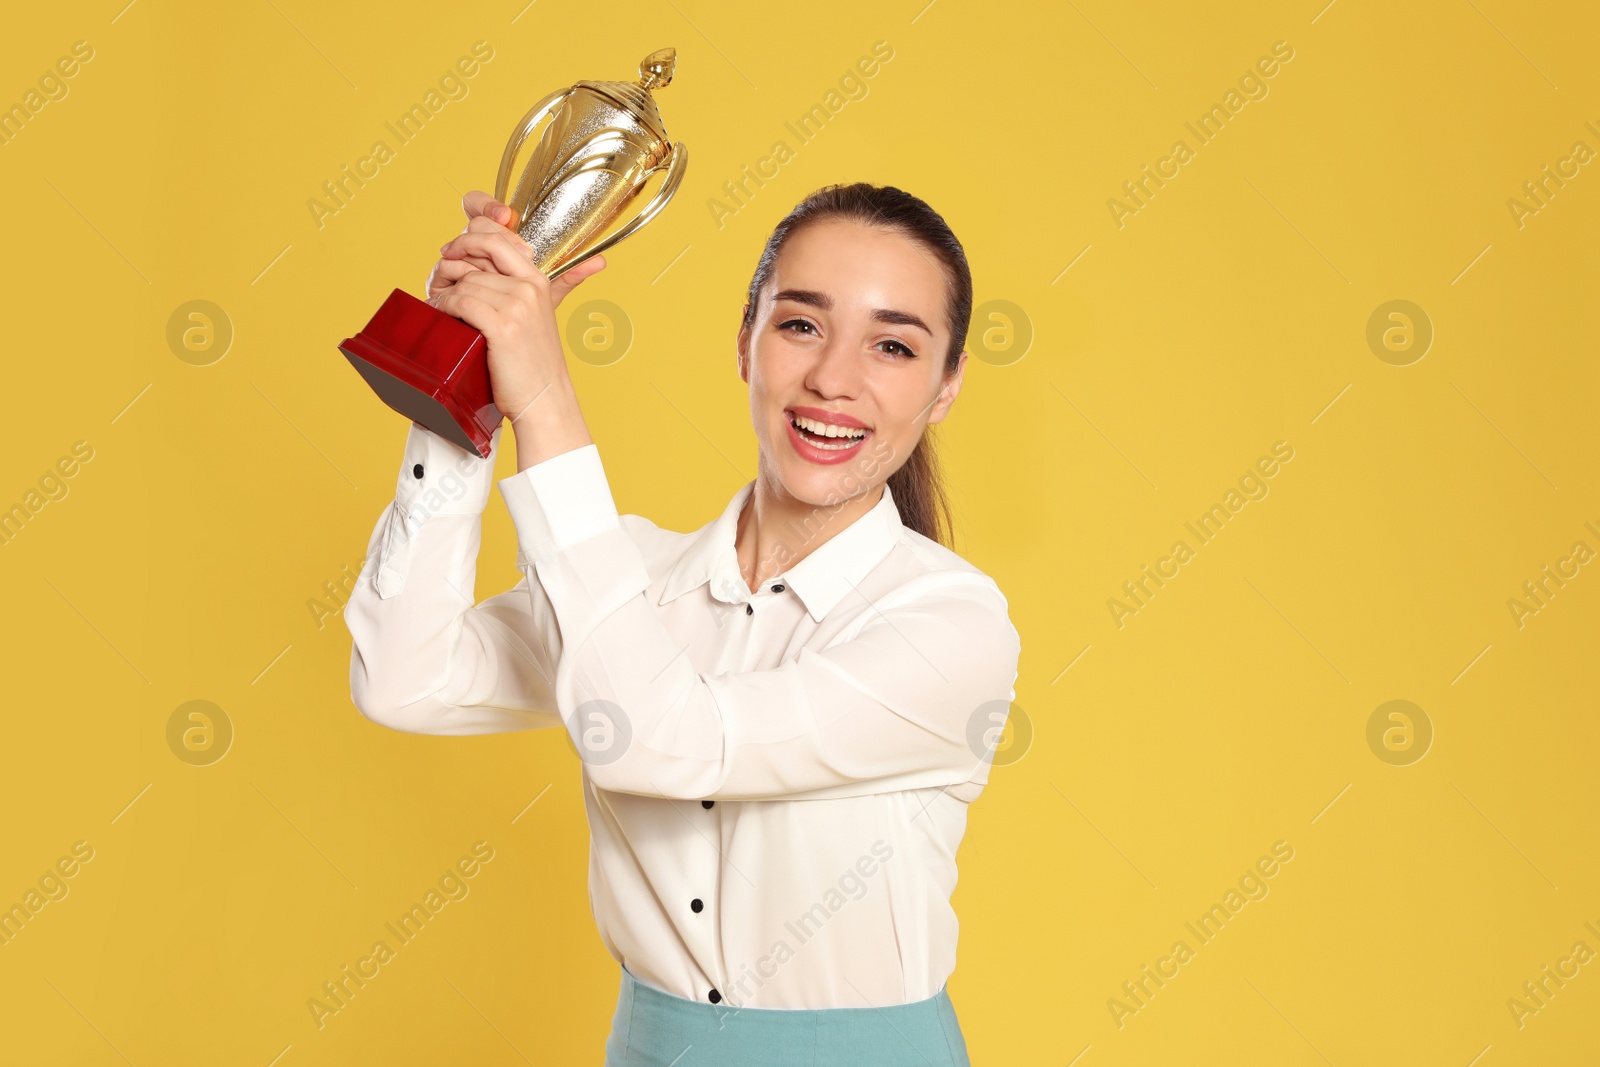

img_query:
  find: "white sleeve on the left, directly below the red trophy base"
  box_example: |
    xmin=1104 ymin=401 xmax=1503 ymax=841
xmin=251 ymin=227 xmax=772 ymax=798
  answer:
xmin=344 ymin=422 xmax=562 ymax=734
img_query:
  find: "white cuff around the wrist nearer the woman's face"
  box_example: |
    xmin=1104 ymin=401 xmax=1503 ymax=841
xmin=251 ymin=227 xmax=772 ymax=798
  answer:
xmin=499 ymin=445 xmax=622 ymax=568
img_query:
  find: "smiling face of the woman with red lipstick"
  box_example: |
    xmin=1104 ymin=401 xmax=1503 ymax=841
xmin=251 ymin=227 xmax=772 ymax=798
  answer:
xmin=738 ymin=219 xmax=966 ymax=506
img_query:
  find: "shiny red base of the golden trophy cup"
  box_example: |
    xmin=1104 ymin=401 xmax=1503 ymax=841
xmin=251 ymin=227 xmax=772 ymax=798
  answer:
xmin=339 ymin=290 xmax=506 ymax=458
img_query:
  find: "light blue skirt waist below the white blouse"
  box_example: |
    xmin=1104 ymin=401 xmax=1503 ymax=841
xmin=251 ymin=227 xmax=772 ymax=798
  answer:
xmin=605 ymin=968 xmax=971 ymax=1067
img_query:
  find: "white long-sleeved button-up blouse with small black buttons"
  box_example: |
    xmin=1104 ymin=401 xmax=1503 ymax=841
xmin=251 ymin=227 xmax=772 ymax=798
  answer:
xmin=344 ymin=424 xmax=1021 ymax=1008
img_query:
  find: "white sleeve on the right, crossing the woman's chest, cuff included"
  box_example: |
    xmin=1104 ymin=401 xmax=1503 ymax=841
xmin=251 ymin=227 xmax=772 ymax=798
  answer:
xmin=499 ymin=445 xmax=1021 ymax=800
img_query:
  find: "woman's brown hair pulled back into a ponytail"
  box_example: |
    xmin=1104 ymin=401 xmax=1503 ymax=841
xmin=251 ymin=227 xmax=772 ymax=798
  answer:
xmin=744 ymin=182 xmax=973 ymax=547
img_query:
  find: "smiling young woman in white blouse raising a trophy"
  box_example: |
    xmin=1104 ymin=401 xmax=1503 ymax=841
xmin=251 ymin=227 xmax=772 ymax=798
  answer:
xmin=344 ymin=184 xmax=1021 ymax=1067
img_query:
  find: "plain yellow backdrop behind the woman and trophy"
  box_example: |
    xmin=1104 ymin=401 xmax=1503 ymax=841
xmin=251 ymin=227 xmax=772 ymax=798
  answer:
xmin=0 ymin=0 xmax=1600 ymax=1067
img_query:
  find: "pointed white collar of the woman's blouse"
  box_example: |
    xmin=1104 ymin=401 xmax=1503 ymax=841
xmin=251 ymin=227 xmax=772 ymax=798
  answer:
xmin=656 ymin=482 xmax=906 ymax=622
